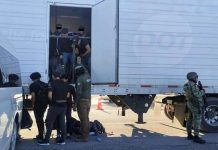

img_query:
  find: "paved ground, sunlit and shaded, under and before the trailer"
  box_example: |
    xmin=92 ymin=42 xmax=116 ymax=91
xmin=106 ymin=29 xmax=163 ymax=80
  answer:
xmin=16 ymin=95 xmax=218 ymax=150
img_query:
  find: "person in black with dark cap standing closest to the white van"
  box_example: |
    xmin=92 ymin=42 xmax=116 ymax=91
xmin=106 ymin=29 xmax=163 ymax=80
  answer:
xmin=30 ymin=72 xmax=48 ymax=140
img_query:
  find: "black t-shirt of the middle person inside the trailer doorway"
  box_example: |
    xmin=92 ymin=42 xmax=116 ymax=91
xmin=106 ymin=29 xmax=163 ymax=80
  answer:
xmin=59 ymin=37 xmax=73 ymax=53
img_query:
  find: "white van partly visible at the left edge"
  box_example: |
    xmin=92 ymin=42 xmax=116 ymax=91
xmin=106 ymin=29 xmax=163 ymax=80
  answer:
xmin=0 ymin=41 xmax=23 ymax=150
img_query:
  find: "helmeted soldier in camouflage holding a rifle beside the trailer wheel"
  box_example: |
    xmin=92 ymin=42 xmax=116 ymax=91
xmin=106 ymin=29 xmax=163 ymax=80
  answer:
xmin=184 ymin=72 xmax=205 ymax=144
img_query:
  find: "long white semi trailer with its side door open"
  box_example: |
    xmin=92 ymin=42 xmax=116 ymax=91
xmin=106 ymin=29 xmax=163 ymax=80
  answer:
xmin=0 ymin=0 xmax=218 ymax=132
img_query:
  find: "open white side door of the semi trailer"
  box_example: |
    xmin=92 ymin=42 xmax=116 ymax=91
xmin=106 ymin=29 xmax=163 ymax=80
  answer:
xmin=91 ymin=0 xmax=118 ymax=84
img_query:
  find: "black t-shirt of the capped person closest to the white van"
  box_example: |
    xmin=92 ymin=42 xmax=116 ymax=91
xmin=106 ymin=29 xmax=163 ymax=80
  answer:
xmin=30 ymin=80 xmax=48 ymax=106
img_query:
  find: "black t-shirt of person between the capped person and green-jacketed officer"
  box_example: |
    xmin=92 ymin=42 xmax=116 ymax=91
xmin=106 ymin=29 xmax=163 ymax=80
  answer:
xmin=49 ymin=79 xmax=70 ymax=107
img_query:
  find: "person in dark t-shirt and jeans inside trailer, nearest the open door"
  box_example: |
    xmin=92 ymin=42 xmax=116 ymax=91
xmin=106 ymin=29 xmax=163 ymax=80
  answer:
xmin=77 ymin=26 xmax=91 ymax=74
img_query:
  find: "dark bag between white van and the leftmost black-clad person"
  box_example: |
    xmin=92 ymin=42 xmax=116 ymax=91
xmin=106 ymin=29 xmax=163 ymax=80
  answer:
xmin=21 ymin=109 xmax=33 ymax=129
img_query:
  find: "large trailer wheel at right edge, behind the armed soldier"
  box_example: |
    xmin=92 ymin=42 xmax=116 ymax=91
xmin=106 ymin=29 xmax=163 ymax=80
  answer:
xmin=201 ymin=97 xmax=218 ymax=132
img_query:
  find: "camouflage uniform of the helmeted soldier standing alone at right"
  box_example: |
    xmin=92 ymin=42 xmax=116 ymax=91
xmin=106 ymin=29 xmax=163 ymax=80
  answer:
xmin=184 ymin=81 xmax=204 ymax=136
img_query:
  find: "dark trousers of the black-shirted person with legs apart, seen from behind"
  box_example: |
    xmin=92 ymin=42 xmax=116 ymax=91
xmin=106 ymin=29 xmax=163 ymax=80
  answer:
xmin=45 ymin=106 xmax=66 ymax=141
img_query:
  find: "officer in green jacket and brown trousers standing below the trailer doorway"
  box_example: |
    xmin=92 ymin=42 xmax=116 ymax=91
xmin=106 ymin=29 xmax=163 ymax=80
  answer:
xmin=75 ymin=65 xmax=91 ymax=142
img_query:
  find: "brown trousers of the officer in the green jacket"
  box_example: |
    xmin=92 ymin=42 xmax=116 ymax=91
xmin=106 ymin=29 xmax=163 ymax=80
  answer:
xmin=77 ymin=100 xmax=91 ymax=139
